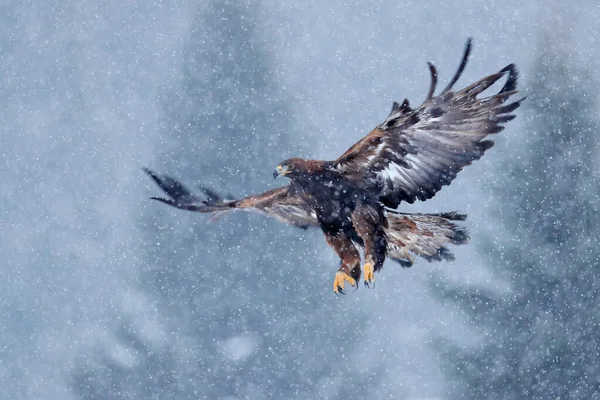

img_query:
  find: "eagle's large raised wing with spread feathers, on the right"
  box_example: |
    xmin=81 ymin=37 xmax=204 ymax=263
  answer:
xmin=333 ymin=39 xmax=524 ymax=208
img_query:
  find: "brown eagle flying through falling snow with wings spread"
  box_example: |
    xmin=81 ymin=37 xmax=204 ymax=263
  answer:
xmin=145 ymin=39 xmax=524 ymax=294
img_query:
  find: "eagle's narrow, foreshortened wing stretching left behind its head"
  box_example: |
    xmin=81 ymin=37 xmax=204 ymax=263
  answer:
xmin=144 ymin=168 xmax=319 ymax=228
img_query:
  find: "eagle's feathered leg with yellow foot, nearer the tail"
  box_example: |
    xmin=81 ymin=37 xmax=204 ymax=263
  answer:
xmin=352 ymin=206 xmax=387 ymax=287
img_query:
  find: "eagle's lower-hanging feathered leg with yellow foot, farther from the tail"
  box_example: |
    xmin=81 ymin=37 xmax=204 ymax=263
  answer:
xmin=325 ymin=232 xmax=360 ymax=294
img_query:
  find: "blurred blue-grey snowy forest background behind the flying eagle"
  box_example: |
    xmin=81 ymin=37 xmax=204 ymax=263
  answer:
xmin=0 ymin=0 xmax=600 ymax=400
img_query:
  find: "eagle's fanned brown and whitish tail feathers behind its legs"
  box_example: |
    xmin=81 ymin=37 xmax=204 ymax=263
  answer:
xmin=385 ymin=210 xmax=469 ymax=268
